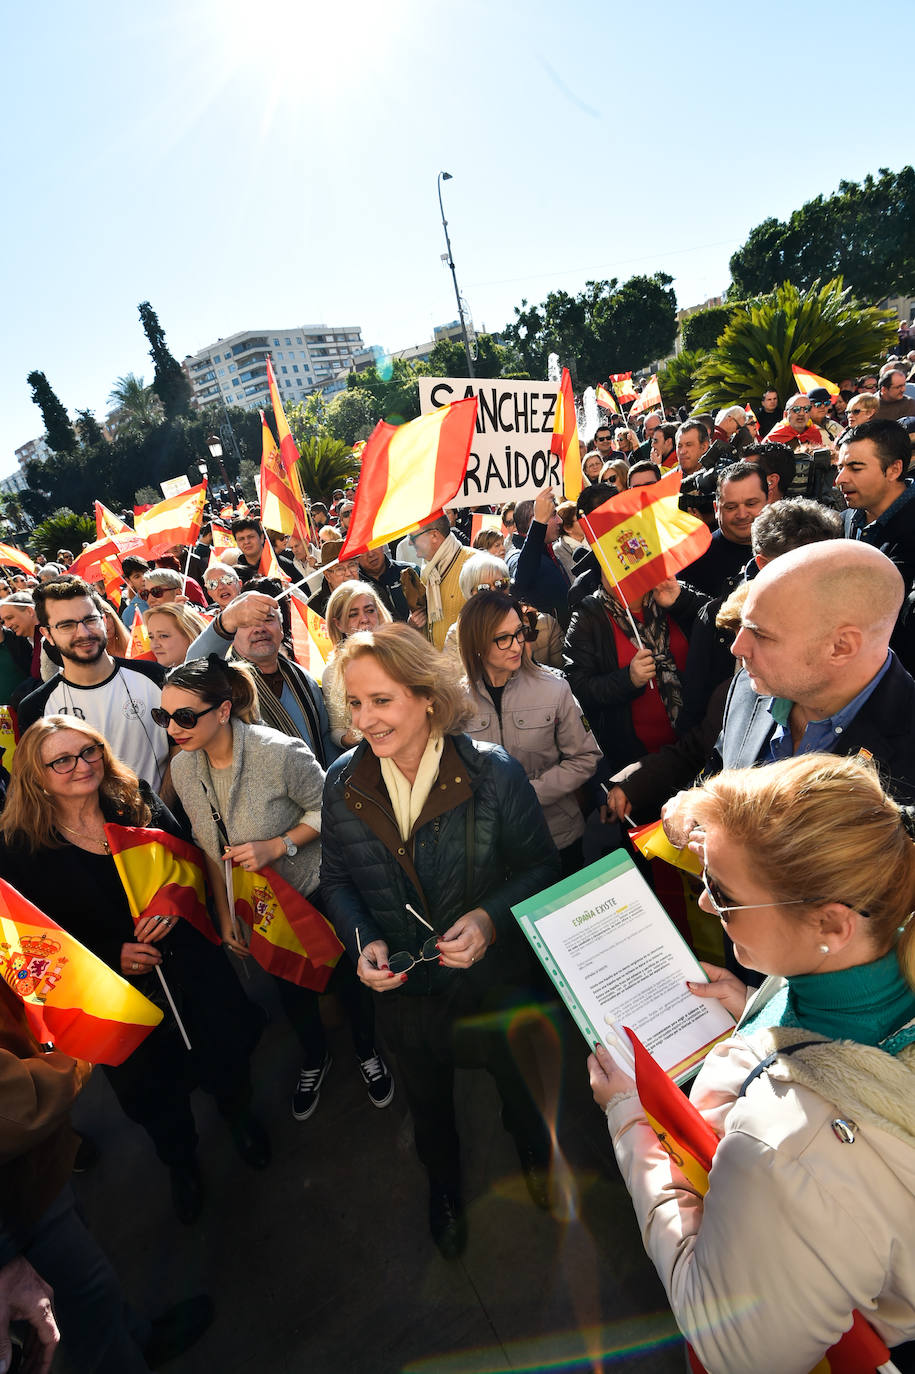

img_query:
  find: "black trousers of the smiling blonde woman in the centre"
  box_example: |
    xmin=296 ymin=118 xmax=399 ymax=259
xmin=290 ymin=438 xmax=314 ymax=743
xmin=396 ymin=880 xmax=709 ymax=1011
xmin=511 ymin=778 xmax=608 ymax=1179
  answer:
xmin=375 ymin=976 xmax=550 ymax=1193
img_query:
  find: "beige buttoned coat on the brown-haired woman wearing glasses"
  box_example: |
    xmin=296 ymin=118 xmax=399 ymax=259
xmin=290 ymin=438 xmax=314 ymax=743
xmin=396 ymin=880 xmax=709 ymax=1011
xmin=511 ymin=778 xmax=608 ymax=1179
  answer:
xmin=466 ymin=665 xmax=603 ymax=849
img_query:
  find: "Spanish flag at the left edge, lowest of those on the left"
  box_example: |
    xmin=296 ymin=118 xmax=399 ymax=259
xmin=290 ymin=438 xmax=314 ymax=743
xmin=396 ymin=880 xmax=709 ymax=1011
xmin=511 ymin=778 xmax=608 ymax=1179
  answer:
xmin=0 ymin=878 xmax=162 ymax=1065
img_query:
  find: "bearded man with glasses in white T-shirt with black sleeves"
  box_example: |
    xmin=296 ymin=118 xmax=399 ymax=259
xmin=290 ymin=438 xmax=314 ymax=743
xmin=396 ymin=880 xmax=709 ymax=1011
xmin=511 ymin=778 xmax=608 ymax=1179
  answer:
xmin=18 ymin=577 xmax=169 ymax=791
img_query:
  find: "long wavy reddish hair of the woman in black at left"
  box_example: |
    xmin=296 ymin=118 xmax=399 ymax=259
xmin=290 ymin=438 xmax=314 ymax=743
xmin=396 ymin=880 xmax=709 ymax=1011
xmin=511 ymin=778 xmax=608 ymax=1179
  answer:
xmin=0 ymin=716 xmax=151 ymax=853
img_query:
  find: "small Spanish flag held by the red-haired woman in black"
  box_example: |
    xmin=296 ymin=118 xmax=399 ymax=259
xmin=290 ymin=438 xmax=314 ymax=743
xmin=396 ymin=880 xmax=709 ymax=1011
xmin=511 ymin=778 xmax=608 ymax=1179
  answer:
xmin=104 ymin=823 xmax=220 ymax=944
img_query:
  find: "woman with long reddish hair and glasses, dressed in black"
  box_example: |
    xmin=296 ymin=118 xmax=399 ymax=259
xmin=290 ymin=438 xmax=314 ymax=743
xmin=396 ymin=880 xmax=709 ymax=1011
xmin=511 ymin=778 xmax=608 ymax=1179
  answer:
xmin=0 ymin=716 xmax=269 ymax=1223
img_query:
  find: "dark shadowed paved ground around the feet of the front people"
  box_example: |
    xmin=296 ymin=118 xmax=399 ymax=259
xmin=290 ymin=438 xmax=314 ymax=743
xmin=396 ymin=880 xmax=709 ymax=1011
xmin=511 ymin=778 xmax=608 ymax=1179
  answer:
xmin=67 ymin=974 xmax=684 ymax=1374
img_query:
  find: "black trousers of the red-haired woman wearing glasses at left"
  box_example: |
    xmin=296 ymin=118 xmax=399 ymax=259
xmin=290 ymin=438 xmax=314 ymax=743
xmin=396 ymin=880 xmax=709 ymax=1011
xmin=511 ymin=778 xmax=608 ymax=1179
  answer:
xmin=104 ymin=922 xmax=264 ymax=1165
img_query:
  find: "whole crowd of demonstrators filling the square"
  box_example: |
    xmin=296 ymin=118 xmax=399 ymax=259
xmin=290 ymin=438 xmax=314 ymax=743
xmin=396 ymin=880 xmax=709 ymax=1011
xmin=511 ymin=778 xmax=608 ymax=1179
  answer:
xmin=0 ymin=348 xmax=915 ymax=1374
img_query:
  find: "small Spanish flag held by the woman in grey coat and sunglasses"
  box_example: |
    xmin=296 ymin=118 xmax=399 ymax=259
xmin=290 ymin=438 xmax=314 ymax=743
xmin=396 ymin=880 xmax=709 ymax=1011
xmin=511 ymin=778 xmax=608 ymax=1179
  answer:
xmin=232 ymin=864 xmax=343 ymax=992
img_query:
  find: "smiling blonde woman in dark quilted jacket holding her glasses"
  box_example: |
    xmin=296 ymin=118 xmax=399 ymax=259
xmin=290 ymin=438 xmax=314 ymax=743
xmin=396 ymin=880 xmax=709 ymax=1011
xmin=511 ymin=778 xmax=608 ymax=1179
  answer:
xmin=321 ymin=624 xmax=559 ymax=1259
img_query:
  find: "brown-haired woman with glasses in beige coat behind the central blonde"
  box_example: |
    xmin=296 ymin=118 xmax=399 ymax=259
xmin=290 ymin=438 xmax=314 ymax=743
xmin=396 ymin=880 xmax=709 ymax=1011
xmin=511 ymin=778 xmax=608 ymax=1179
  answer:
xmin=458 ymin=592 xmax=602 ymax=877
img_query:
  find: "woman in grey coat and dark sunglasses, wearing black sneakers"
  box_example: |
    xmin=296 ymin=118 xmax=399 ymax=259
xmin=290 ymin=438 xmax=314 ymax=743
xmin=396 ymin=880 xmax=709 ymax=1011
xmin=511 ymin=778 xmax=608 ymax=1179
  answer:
xmin=162 ymin=654 xmax=394 ymax=1121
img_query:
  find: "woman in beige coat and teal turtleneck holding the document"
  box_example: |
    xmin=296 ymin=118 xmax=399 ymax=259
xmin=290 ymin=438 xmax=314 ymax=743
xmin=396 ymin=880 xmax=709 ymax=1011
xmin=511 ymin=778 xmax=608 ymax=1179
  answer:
xmin=588 ymin=754 xmax=915 ymax=1374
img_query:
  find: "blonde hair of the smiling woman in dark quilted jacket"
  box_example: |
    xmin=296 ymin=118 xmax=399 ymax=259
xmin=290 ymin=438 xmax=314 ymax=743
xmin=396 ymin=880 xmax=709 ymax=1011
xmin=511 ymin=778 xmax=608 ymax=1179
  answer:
xmin=337 ymin=621 xmax=473 ymax=735
